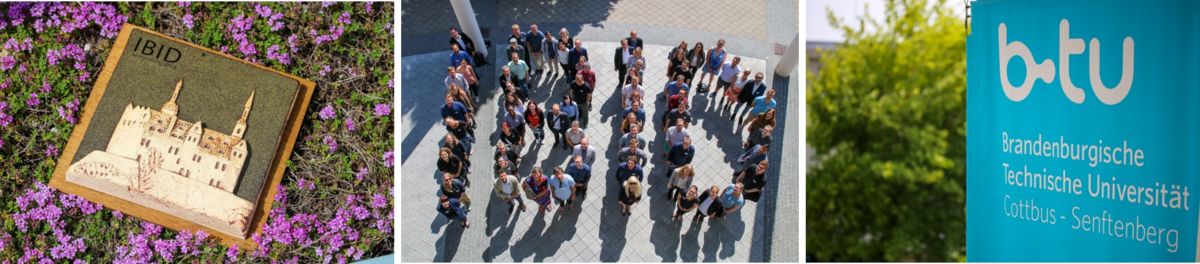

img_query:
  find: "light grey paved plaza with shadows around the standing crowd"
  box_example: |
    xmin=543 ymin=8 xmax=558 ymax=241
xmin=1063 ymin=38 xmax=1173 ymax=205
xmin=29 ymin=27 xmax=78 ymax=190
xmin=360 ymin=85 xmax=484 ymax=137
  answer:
xmin=397 ymin=0 xmax=804 ymax=263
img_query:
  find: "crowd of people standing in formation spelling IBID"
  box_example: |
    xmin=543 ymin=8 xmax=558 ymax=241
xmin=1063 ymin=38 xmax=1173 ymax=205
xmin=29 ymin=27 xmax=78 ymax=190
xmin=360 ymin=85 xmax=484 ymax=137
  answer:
xmin=437 ymin=24 xmax=776 ymax=227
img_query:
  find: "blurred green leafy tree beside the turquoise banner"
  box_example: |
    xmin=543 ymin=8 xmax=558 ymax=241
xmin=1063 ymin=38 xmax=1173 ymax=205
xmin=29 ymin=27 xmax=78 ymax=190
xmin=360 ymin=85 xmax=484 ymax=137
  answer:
xmin=804 ymin=0 xmax=968 ymax=263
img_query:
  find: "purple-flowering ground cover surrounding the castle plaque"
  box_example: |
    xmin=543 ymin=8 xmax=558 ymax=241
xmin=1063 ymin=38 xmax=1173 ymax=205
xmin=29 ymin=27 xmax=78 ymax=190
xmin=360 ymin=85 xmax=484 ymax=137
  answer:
xmin=0 ymin=0 xmax=396 ymax=264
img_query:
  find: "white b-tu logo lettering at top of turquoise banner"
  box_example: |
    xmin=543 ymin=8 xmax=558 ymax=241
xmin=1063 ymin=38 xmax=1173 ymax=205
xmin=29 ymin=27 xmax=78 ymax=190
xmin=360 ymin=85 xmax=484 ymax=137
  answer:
xmin=1000 ymin=19 xmax=1133 ymax=104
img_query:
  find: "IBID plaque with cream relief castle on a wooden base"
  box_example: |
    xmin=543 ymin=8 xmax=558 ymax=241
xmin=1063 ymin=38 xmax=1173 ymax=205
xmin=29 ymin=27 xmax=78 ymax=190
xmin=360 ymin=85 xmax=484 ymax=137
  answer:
xmin=50 ymin=24 xmax=314 ymax=247
